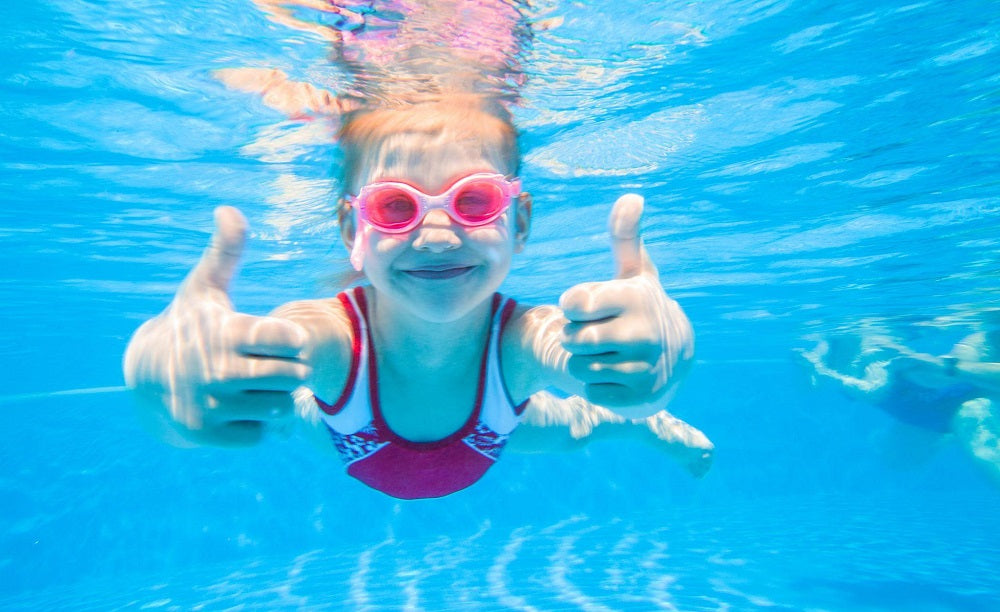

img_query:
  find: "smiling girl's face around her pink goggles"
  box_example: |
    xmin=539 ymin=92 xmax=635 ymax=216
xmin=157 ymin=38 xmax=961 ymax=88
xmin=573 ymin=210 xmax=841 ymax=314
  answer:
xmin=341 ymin=133 xmax=531 ymax=322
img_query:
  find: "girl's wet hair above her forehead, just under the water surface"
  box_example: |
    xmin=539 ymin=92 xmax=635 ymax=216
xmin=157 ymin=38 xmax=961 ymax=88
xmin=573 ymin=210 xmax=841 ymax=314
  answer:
xmin=337 ymin=94 xmax=521 ymax=198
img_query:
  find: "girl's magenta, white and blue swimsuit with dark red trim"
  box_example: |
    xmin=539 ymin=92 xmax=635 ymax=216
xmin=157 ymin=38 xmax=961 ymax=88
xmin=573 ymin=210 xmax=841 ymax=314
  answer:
xmin=314 ymin=287 xmax=528 ymax=499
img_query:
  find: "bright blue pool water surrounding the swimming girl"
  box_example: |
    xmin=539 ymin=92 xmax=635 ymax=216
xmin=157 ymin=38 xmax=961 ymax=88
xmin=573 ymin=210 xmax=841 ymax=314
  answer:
xmin=0 ymin=0 xmax=1000 ymax=610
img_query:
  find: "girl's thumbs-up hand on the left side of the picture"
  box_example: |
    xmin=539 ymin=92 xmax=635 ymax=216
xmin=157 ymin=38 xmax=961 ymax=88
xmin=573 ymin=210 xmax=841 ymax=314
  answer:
xmin=125 ymin=206 xmax=309 ymax=445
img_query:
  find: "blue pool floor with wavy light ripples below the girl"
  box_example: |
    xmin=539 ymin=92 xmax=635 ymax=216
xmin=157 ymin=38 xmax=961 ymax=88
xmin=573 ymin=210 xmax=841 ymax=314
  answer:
xmin=0 ymin=498 xmax=1000 ymax=610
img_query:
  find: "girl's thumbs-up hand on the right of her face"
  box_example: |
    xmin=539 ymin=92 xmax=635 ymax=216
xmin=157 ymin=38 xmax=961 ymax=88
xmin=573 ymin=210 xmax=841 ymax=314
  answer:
xmin=559 ymin=194 xmax=694 ymax=418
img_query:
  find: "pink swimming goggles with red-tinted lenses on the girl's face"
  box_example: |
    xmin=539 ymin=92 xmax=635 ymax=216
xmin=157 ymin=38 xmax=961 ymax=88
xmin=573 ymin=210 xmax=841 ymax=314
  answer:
xmin=347 ymin=172 xmax=521 ymax=271
